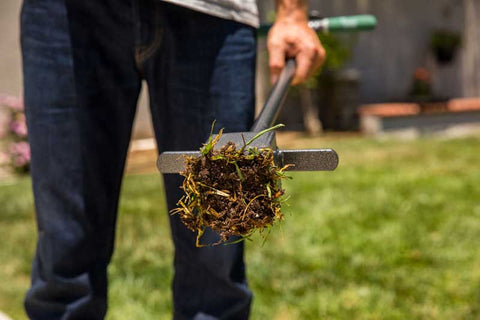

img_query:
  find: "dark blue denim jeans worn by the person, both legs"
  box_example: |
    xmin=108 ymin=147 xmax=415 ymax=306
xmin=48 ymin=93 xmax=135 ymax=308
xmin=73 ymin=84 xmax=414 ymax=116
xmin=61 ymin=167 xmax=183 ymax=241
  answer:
xmin=21 ymin=0 xmax=256 ymax=320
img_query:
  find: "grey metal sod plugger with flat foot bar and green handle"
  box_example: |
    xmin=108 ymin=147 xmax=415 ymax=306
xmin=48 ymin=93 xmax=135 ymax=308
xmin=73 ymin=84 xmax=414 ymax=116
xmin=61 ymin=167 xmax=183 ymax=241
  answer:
xmin=157 ymin=15 xmax=376 ymax=173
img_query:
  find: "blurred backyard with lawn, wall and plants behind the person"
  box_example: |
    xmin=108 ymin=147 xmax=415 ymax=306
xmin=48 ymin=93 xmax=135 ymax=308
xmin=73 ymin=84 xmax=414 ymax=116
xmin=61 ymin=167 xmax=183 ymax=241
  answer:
xmin=0 ymin=0 xmax=480 ymax=319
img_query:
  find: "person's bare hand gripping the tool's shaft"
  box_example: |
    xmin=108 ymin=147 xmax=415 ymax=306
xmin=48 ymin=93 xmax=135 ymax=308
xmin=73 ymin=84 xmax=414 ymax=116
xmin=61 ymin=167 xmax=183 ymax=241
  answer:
xmin=267 ymin=11 xmax=325 ymax=85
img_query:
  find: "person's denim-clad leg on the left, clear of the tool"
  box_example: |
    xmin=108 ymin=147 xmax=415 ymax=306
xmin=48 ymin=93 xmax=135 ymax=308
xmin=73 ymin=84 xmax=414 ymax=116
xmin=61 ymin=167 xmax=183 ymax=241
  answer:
xmin=21 ymin=0 xmax=140 ymax=320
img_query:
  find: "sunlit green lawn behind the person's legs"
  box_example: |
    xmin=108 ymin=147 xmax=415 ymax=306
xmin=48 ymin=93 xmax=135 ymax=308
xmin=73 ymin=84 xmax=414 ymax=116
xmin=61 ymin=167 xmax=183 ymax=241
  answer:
xmin=0 ymin=138 xmax=480 ymax=320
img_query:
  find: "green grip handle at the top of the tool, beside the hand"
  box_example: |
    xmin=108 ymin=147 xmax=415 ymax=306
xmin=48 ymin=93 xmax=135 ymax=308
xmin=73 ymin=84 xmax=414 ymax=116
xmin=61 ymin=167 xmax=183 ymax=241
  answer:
xmin=258 ymin=14 xmax=377 ymax=35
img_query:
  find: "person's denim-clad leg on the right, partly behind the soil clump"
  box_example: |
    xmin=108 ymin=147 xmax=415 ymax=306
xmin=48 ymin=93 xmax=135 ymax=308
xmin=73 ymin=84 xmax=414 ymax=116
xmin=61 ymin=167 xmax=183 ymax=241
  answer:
xmin=143 ymin=1 xmax=256 ymax=320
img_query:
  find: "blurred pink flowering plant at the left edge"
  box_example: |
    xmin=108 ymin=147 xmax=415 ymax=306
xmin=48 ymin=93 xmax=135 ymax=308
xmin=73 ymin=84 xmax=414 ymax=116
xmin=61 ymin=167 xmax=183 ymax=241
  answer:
xmin=0 ymin=94 xmax=30 ymax=173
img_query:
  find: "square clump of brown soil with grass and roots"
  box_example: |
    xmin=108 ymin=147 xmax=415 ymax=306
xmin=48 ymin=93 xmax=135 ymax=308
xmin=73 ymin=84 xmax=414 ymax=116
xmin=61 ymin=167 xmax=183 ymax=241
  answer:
xmin=171 ymin=125 xmax=288 ymax=246
